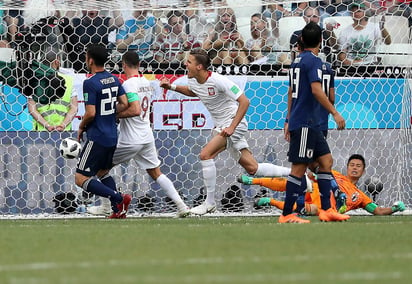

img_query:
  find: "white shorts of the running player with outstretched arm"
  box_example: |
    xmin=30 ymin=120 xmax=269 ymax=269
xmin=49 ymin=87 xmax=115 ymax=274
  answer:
xmin=212 ymin=120 xmax=249 ymax=161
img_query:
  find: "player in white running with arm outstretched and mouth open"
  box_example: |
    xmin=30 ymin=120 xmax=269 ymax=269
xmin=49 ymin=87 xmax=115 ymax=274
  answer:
xmin=160 ymin=49 xmax=289 ymax=215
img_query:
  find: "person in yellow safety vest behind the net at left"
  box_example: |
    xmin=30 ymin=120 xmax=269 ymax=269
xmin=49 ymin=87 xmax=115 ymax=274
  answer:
xmin=24 ymin=50 xmax=77 ymax=131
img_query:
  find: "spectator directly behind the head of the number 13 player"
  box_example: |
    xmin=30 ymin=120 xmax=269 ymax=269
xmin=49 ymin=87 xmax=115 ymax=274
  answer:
xmin=290 ymin=7 xmax=337 ymax=63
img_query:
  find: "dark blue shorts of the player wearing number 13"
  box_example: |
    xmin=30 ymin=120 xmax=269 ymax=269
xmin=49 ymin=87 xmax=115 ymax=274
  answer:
xmin=288 ymin=127 xmax=330 ymax=164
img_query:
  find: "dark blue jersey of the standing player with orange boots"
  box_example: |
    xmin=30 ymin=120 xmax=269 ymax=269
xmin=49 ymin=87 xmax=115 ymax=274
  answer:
xmin=289 ymin=51 xmax=322 ymax=130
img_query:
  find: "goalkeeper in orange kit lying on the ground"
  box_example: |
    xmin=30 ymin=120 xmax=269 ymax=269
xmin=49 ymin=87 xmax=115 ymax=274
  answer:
xmin=239 ymin=154 xmax=405 ymax=215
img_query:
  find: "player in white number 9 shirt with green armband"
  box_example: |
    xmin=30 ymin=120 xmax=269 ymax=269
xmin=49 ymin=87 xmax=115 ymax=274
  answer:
xmin=89 ymin=51 xmax=190 ymax=218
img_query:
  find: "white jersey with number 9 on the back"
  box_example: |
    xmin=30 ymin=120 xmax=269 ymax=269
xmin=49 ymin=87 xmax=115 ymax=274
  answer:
xmin=119 ymin=75 xmax=154 ymax=145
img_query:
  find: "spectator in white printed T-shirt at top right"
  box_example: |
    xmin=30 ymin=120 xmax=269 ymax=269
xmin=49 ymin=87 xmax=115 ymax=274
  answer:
xmin=338 ymin=3 xmax=391 ymax=65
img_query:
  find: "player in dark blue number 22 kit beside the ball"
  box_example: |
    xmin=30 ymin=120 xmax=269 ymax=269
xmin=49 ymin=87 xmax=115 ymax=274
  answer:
xmin=75 ymin=45 xmax=131 ymax=219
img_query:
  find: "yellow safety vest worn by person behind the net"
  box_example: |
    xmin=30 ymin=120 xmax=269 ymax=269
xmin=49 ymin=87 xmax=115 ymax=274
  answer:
xmin=33 ymin=73 xmax=74 ymax=131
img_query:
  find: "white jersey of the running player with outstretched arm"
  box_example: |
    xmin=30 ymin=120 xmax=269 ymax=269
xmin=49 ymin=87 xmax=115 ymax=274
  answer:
xmin=188 ymin=72 xmax=246 ymax=128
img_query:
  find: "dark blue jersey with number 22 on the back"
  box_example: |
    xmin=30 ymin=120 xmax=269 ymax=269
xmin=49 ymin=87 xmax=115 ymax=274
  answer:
xmin=83 ymin=71 xmax=125 ymax=147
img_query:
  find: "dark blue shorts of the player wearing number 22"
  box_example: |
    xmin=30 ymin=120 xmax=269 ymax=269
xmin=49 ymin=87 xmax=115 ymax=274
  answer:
xmin=76 ymin=140 xmax=116 ymax=177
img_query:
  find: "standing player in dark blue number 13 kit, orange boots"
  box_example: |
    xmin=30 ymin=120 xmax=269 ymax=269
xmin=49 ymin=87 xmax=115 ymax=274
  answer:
xmin=279 ymin=23 xmax=349 ymax=223
